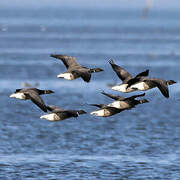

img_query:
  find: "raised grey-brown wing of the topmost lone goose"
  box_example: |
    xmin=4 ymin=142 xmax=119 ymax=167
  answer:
xmin=51 ymin=54 xmax=80 ymax=69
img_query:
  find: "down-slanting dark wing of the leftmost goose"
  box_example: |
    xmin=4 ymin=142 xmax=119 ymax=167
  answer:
xmin=24 ymin=90 xmax=47 ymax=112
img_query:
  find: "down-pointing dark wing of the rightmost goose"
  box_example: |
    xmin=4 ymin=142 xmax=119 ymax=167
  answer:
xmin=144 ymin=78 xmax=169 ymax=98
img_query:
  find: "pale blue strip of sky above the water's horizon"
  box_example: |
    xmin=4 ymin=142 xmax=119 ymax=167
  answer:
xmin=0 ymin=0 xmax=180 ymax=9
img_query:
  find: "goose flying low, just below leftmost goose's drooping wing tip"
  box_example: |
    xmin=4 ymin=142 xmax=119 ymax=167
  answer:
xmin=40 ymin=105 xmax=86 ymax=121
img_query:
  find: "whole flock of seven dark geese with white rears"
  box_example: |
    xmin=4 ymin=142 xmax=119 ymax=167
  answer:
xmin=10 ymin=54 xmax=176 ymax=121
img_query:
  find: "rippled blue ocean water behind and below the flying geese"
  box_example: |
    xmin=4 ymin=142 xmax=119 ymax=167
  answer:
xmin=0 ymin=8 xmax=180 ymax=180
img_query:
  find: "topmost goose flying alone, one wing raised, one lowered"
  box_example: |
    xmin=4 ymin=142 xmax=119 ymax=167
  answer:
xmin=50 ymin=54 xmax=103 ymax=82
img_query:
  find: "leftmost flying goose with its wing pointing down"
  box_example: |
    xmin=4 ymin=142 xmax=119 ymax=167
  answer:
xmin=9 ymin=88 xmax=54 ymax=112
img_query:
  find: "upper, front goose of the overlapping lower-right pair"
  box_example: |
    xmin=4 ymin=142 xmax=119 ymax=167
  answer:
xmin=102 ymin=92 xmax=149 ymax=109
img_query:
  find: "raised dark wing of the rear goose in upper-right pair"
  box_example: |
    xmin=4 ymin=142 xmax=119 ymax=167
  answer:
xmin=109 ymin=60 xmax=132 ymax=81
